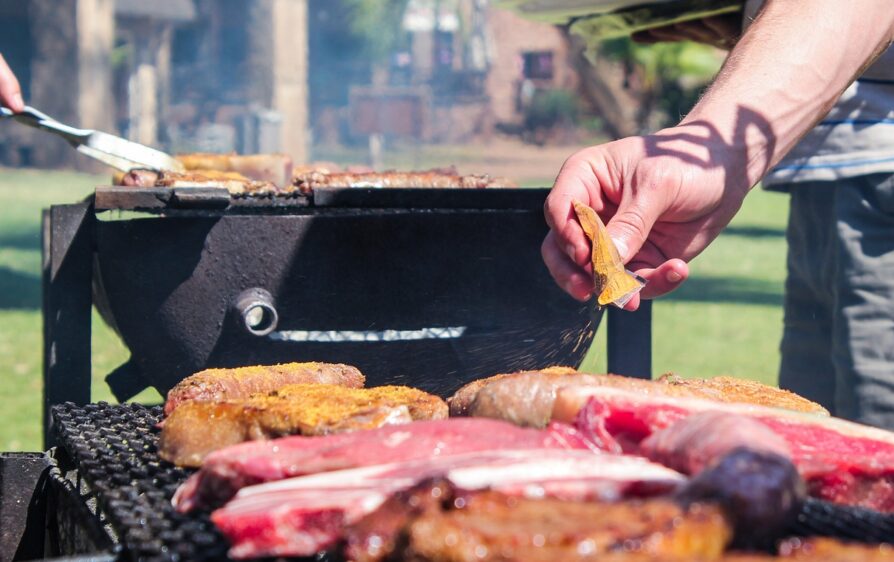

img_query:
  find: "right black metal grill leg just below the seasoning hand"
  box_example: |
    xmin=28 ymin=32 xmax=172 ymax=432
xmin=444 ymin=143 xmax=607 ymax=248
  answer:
xmin=606 ymin=301 xmax=652 ymax=379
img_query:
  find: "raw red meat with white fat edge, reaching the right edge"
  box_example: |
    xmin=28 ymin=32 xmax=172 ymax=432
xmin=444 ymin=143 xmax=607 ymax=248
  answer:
xmin=553 ymin=386 xmax=894 ymax=512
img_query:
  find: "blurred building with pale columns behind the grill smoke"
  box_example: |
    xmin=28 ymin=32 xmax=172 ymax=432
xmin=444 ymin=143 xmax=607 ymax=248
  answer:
xmin=0 ymin=0 xmax=719 ymax=167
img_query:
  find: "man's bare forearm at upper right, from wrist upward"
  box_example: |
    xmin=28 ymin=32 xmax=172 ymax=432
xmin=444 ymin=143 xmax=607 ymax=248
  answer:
xmin=681 ymin=0 xmax=894 ymax=187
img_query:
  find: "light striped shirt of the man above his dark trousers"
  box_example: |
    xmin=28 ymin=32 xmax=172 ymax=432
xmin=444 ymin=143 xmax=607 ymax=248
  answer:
xmin=745 ymin=0 xmax=894 ymax=186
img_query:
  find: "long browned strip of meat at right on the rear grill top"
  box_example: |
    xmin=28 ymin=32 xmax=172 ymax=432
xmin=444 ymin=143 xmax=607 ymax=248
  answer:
xmin=292 ymin=170 xmax=517 ymax=194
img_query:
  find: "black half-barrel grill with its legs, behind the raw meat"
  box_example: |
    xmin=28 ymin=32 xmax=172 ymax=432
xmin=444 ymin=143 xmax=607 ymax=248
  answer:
xmin=44 ymin=184 xmax=651 ymax=442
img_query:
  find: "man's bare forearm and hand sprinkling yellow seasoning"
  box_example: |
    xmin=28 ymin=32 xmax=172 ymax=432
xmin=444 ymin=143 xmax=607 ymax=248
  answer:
xmin=543 ymin=0 xmax=894 ymax=309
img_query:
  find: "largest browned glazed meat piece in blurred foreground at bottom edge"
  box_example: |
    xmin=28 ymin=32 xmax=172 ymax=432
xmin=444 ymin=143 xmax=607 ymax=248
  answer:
xmin=346 ymin=476 xmax=730 ymax=562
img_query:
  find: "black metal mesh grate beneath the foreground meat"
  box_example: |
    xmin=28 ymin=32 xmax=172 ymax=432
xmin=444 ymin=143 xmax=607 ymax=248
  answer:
xmin=52 ymin=402 xmax=894 ymax=562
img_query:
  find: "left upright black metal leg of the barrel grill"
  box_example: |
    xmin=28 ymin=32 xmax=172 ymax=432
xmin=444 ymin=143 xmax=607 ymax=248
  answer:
xmin=42 ymin=203 xmax=95 ymax=448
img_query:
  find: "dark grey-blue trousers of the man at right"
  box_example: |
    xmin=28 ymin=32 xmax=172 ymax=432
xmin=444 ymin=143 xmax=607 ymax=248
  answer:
xmin=779 ymin=174 xmax=894 ymax=429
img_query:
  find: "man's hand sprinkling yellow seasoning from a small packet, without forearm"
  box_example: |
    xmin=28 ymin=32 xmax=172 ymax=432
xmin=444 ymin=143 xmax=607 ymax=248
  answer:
xmin=542 ymin=123 xmax=751 ymax=310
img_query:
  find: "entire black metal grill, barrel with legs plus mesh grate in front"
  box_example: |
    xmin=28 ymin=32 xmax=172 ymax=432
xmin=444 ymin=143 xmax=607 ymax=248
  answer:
xmin=31 ymin=183 xmax=651 ymax=560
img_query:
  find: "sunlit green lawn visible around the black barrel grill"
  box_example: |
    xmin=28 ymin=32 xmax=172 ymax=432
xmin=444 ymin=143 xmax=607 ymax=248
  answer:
xmin=0 ymin=164 xmax=788 ymax=451
